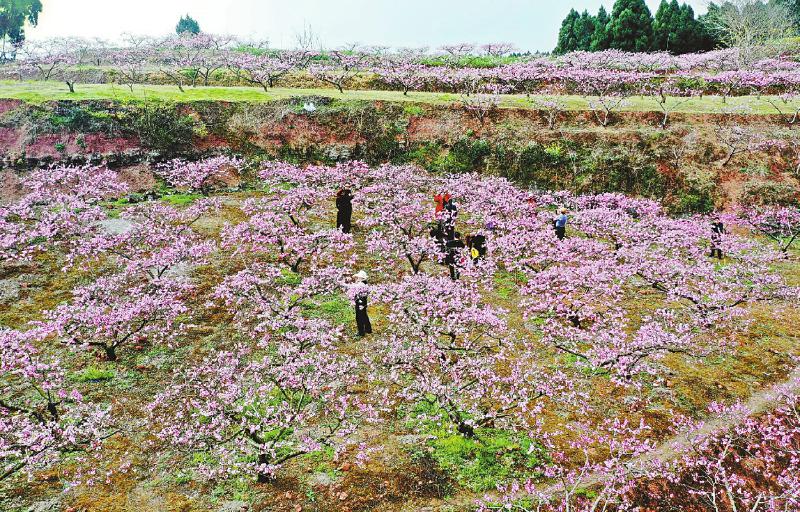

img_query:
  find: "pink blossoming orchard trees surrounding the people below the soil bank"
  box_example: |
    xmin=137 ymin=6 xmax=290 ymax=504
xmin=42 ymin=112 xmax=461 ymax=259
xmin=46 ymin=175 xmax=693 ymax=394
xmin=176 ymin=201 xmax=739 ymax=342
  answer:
xmin=0 ymin=159 xmax=800 ymax=499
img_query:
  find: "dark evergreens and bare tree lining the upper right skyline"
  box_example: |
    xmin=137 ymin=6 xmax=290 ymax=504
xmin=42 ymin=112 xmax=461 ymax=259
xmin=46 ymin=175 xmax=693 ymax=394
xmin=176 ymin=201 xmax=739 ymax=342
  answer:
xmin=553 ymin=0 xmax=800 ymax=55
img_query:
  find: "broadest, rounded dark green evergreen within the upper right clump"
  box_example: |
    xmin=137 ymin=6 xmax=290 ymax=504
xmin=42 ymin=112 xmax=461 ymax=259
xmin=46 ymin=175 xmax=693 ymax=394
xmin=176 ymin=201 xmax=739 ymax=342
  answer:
xmin=607 ymin=0 xmax=653 ymax=52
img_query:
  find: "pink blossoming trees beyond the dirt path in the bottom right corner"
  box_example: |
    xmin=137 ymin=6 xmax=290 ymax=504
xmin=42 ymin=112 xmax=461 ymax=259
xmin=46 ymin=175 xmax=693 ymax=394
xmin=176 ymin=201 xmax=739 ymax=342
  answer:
xmin=479 ymin=381 xmax=800 ymax=512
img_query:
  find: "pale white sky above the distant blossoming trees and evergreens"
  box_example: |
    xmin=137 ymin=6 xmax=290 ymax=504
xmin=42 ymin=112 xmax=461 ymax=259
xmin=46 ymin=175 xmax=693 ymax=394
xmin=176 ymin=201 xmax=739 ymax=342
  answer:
xmin=28 ymin=0 xmax=706 ymax=51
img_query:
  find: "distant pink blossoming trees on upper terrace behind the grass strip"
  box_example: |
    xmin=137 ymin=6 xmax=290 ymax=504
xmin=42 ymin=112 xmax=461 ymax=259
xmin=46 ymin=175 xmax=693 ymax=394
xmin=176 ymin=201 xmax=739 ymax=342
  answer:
xmin=3 ymin=34 xmax=800 ymax=100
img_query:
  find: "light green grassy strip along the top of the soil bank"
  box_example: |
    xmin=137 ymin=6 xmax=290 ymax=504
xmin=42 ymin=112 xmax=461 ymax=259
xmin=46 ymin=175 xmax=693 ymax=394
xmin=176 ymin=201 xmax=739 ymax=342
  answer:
xmin=0 ymin=81 xmax=800 ymax=114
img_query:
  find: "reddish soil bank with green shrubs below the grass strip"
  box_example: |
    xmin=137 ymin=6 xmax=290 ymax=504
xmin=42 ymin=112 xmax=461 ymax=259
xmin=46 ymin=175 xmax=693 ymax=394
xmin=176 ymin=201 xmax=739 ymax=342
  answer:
xmin=0 ymin=97 xmax=800 ymax=212
